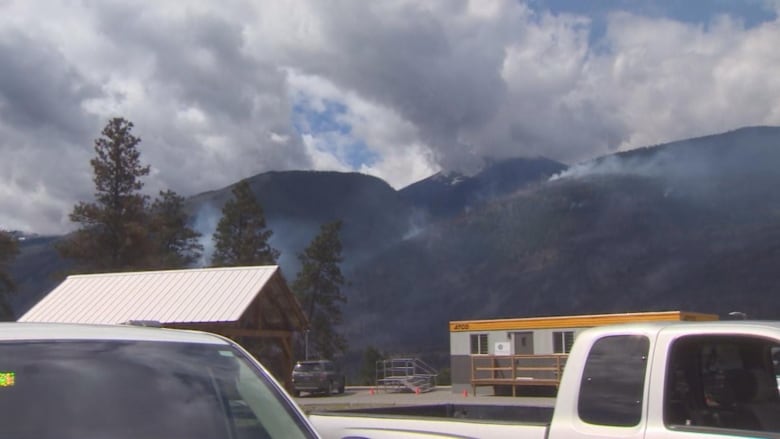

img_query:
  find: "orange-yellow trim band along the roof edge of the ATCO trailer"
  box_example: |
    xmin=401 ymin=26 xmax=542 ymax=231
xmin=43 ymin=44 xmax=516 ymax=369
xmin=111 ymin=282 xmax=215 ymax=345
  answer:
xmin=450 ymin=311 xmax=718 ymax=332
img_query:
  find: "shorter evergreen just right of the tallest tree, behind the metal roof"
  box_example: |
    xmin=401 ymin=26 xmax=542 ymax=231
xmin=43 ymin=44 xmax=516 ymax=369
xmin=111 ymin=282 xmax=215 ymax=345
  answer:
xmin=149 ymin=190 xmax=203 ymax=269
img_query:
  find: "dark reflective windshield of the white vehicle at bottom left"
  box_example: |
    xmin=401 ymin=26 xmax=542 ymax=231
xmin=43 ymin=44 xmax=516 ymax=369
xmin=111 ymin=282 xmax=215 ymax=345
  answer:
xmin=0 ymin=341 xmax=315 ymax=439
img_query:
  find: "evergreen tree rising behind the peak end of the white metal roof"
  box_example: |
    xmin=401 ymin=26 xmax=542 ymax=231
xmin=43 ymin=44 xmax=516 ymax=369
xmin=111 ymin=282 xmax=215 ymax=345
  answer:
xmin=211 ymin=180 xmax=279 ymax=267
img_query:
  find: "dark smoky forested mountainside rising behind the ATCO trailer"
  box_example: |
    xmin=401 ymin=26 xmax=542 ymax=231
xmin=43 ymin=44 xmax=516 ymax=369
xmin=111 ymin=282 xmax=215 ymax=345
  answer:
xmin=347 ymin=127 xmax=780 ymax=351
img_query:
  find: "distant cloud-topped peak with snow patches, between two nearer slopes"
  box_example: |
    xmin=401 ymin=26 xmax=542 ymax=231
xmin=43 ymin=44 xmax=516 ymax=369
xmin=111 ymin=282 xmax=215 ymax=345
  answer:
xmin=399 ymin=158 xmax=566 ymax=218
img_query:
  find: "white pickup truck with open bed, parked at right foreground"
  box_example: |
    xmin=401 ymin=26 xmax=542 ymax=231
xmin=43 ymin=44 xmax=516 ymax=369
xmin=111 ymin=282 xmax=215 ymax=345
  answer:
xmin=309 ymin=321 xmax=780 ymax=439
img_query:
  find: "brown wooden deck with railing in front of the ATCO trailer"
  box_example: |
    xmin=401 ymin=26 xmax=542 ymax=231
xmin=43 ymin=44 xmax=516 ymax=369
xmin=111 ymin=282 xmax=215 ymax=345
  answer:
xmin=471 ymin=354 xmax=568 ymax=396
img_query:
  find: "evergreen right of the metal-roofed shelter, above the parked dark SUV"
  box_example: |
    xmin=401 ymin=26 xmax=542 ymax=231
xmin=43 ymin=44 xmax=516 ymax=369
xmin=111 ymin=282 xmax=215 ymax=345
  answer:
xmin=292 ymin=221 xmax=347 ymax=359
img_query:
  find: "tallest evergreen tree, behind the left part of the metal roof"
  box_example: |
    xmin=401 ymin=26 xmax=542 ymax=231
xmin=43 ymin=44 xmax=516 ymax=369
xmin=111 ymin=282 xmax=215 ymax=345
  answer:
xmin=58 ymin=117 xmax=149 ymax=271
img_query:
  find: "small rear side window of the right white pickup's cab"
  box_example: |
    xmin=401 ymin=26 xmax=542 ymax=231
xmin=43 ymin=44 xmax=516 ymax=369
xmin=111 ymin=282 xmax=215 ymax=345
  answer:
xmin=577 ymin=335 xmax=650 ymax=427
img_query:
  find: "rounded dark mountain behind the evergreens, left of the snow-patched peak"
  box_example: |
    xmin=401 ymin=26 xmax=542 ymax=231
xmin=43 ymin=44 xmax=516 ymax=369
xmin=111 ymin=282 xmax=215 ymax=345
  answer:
xmin=185 ymin=171 xmax=412 ymax=272
